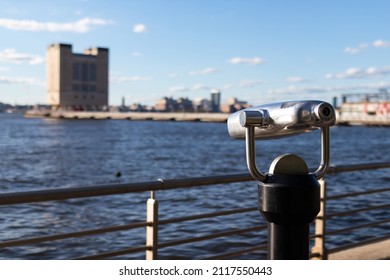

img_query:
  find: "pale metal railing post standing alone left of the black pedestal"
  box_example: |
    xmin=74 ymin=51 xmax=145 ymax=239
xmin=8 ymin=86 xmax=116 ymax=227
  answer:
xmin=146 ymin=191 xmax=158 ymax=260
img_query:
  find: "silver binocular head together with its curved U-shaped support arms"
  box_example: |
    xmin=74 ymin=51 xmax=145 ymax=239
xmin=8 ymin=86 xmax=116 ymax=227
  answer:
xmin=227 ymin=100 xmax=336 ymax=182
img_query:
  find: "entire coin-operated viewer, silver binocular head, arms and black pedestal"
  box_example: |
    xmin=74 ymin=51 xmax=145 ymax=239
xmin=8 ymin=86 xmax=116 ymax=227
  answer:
xmin=227 ymin=100 xmax=336 ymax=260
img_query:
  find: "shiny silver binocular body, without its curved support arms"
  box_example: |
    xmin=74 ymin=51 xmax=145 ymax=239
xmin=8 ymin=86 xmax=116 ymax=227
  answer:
xmin=227 ymin=100 xmax=336 ymax=139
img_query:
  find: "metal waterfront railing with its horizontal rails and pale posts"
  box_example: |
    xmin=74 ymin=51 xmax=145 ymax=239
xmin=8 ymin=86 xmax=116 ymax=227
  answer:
xmin=0 ymin=162 xmax=390 ymax=259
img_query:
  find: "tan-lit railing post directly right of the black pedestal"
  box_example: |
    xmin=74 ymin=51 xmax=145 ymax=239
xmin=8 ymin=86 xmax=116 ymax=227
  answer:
xmin=312 ymin=179 xmax=328 ymax=260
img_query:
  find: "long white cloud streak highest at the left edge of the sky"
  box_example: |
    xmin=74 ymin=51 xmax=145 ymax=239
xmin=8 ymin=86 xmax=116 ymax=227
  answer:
xmin=0 ymin=17 xmax=111 ymax=33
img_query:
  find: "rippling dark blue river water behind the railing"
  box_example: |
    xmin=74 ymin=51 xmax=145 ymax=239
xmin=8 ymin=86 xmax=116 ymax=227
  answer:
xmin=0 ymin=114 xmax=390 ymax=259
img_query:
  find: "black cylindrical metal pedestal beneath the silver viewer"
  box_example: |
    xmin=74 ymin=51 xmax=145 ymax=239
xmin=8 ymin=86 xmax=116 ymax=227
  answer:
xmin=259 ymin=174 xmax=320 ymax=260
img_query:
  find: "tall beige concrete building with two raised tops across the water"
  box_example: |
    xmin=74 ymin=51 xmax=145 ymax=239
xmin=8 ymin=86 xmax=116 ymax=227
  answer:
xmin=46 ymin=44 xmax=109 ymax=110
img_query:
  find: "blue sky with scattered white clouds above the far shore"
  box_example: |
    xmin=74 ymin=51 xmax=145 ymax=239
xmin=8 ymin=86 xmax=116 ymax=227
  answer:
xmin=0 ymin=0 xmax=390 ymax=105
